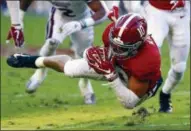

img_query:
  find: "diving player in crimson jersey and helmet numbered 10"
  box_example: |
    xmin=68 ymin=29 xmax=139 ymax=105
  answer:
xmin=7 ymin=9 xmax=162 ymax=109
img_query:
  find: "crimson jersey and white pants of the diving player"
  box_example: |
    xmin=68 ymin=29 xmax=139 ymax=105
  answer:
xmin=64 ymin=24 xmax=161 ymax=95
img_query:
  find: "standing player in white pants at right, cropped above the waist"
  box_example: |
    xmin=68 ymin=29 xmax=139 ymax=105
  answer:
xmin=145 ymin=0 xmax=190 ymax=113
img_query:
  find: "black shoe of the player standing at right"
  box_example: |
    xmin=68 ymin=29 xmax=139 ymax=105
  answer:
xmin=159 ymin=91 xmax=173 ymax=113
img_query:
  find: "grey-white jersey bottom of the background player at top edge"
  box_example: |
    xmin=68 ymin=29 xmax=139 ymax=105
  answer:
xmin=50 ymin=0 xmax=91 ymax=18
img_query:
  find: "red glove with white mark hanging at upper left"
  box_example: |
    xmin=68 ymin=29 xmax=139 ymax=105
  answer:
xmin=6 ymin=25 xmax=24 ymax=47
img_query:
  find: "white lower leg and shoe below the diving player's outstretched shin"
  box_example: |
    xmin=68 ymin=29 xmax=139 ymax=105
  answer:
xmin=26 ymin=68 xmax=48 ymax=93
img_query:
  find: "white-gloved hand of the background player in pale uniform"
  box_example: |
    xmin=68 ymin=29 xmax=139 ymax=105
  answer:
xmin=62 ymin=21 xmax=82 ymax=37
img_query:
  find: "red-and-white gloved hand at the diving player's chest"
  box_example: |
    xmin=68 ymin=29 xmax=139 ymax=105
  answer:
xmin=86 ymin=47 xmax=117 ymax=81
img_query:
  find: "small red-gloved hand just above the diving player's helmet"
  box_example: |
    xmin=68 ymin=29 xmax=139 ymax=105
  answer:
xmin=107 ymin=6 xmax=119 ymax=22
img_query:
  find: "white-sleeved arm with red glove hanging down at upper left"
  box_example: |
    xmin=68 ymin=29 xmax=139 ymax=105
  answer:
xmin=6 ymin=0 xmax=24 ymax=47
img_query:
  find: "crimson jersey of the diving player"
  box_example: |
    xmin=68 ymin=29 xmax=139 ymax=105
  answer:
xmin=102 ymin=23 xmax=161 ymax=88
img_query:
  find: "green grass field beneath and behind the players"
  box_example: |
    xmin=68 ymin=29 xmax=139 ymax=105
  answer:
xmin=1 ymin=15 xmax=190 ymax=130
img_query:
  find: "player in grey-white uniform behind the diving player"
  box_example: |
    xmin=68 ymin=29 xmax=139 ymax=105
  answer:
xmin=12 ymin=0 xmax=107 ymax=104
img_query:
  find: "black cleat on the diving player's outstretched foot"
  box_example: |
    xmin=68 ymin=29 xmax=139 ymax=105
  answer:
xmin=7 ymin=54 xmax=39 ymax=68
